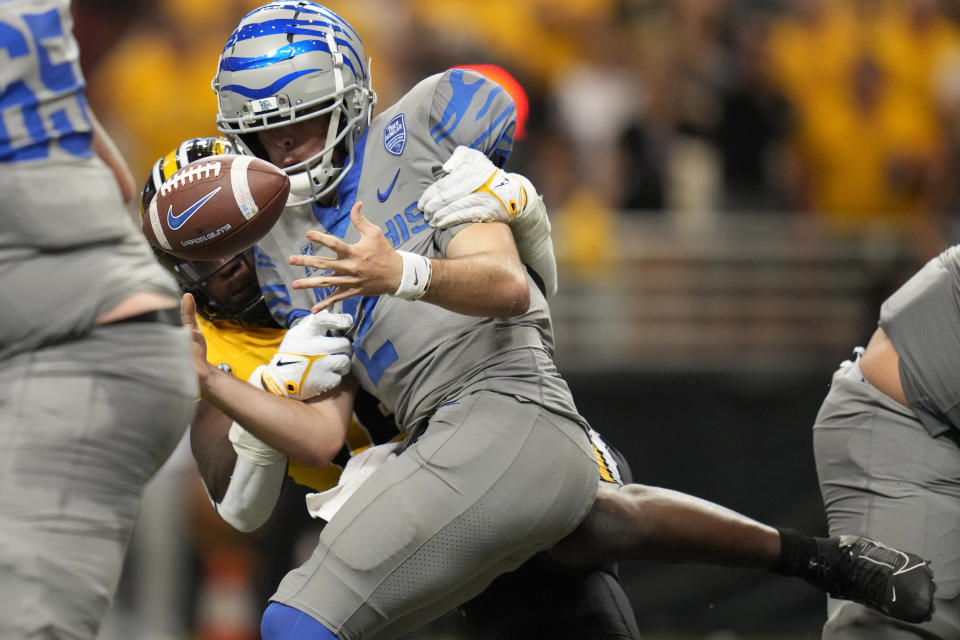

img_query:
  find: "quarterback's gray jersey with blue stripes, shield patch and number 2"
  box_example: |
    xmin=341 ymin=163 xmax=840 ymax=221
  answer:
xmin=256 ymin=69 xmax=582 ymax=429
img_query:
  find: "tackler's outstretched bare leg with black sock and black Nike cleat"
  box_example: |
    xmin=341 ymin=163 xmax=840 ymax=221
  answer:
xmin=552 ymin=370 xmax=932 ymax=621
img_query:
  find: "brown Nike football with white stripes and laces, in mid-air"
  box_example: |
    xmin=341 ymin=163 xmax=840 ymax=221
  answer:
xmin=143 ymin=154 xmax=290 ymax=260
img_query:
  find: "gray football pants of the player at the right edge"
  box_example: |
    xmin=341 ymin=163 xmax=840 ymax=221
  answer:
xmin=813 ymin=364 xmax=960 ymax=640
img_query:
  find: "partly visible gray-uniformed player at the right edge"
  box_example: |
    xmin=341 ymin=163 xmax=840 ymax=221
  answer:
xmin=813 ymin=246 xmax=960 ymax=640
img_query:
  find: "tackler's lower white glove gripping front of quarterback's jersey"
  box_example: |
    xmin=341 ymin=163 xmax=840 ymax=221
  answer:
xmin=258 ymin=311 xmax=353 ymax=400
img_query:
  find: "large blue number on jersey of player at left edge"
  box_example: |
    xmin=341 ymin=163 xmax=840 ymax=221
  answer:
xmin=0 ymin=9 xmax=92 ymax=162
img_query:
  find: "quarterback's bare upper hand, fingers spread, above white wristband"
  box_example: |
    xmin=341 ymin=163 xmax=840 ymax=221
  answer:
xmin=288 ymin=202 xmax=403 ymax=313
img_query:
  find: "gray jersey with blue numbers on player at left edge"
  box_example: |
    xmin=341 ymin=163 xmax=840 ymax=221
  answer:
xmin=0 ymin=0 xmax=178 ymax=357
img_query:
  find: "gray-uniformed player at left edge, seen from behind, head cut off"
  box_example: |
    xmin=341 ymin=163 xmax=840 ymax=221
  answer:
xmin=0 ymin=0 xmax=198 ymax=640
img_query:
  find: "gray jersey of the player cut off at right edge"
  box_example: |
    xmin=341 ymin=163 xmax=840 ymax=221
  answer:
xmin=880 ymin=245 xmax=960 ymax=436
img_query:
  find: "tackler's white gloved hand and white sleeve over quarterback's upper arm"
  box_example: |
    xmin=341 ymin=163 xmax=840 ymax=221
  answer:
xmin=417 ymin=146 xmax=557 ymax=297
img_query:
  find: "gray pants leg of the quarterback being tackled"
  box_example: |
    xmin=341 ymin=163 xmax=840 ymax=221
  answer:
xmin=265 ymin=392 xmax=597 ymax=640
